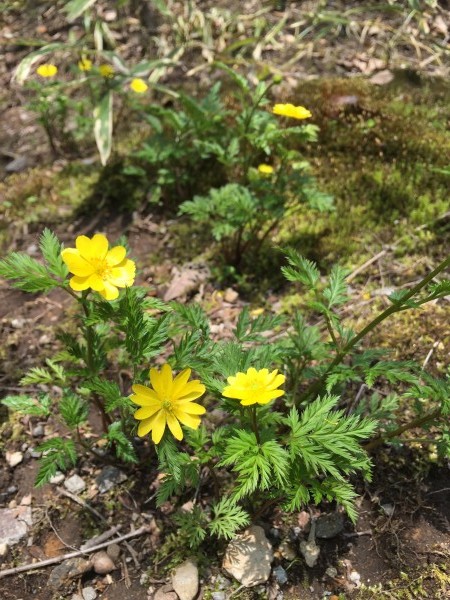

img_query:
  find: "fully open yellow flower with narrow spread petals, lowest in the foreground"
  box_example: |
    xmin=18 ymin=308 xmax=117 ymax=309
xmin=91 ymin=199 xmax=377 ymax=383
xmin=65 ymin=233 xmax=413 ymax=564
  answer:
xmin=130 ymin=364 xmax=206 ymax=444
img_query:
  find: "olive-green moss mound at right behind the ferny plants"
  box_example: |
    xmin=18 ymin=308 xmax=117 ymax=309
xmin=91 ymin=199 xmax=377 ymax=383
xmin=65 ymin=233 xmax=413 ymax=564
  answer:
xmin=281 ymin=79 xmax=450 ymax=264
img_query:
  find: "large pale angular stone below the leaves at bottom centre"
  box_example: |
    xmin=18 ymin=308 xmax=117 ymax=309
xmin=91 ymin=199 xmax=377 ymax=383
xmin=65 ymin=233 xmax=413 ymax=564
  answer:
xmin=222 ymin=525 xmax=273 ymax=587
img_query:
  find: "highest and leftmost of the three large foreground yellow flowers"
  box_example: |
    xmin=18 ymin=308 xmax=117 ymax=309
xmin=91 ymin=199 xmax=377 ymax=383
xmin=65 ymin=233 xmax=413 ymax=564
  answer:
xmin=61 ymin=233 xmax=136 ymax=300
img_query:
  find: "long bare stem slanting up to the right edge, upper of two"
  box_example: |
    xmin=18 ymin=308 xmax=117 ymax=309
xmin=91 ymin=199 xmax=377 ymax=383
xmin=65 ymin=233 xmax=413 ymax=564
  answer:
xmin=299 ymin=257 xmax=450 ymax=402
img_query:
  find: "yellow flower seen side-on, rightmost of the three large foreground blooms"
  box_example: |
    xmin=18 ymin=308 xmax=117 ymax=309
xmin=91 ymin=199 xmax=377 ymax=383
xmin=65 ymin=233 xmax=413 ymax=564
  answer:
xmin=222 ymin=367 xmax=286 ymax=406
